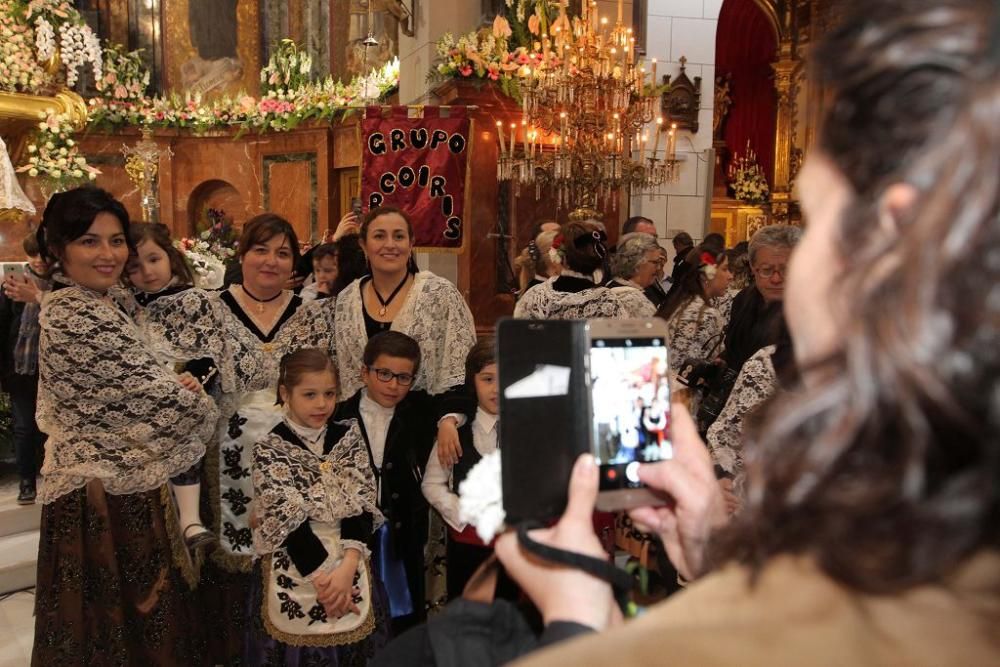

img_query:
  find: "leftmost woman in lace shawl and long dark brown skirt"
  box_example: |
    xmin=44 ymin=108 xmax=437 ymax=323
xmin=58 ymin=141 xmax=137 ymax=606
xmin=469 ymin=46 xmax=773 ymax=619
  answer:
xmin=32 ymin=188 xmax=217 ymax=665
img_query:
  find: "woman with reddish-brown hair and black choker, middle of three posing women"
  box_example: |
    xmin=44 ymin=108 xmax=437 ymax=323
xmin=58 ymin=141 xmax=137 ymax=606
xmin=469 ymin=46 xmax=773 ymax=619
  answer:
xmin=140 ymin=213 xmax=330 ymax=664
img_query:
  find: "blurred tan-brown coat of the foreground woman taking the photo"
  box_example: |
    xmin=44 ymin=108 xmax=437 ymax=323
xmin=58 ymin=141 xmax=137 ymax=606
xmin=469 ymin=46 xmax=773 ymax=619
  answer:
xmin=517 ymin=552 xmax=1000 ymax=667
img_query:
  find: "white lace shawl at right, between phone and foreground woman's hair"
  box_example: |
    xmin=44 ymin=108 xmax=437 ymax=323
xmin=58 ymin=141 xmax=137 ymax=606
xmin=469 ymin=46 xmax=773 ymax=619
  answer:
xmin=708 ymin=345 xmax=778 ymax=475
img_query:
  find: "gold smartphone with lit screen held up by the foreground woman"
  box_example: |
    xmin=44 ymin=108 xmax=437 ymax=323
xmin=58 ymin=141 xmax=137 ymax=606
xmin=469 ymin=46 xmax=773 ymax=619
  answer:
xmin=587 ymin=318 xmax=673 ymax=512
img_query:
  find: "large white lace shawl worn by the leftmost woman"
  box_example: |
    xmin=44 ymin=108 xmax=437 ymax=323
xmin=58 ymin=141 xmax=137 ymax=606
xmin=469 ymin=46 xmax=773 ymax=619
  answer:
xmin=37 ymin=285 xmax=218 ymax=503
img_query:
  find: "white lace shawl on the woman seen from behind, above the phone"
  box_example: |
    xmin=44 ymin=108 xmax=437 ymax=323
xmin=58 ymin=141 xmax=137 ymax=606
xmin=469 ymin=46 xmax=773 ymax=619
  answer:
xmin=514 ymin=278 xmax=640 ymax=320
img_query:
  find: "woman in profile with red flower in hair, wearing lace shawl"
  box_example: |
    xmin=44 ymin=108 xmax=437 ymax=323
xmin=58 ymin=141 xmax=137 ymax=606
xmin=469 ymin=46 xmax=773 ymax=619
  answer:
xmin=656 ymin=246 xmax=732 ymax=380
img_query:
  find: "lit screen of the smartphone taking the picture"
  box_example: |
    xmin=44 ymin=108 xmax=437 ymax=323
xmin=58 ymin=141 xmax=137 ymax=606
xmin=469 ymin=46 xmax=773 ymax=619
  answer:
xmin=590 ymin=337 xmax=673 ymax=490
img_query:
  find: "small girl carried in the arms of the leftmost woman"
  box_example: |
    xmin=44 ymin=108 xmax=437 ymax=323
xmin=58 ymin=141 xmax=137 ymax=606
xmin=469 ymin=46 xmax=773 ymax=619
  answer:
xmin=125 ymin=222 xmax=216 ymax=551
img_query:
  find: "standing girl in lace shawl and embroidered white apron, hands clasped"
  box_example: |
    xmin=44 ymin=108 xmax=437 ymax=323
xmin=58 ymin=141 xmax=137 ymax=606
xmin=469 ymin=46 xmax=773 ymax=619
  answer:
xmin=244 ymin=348 xmax=387 ymax=666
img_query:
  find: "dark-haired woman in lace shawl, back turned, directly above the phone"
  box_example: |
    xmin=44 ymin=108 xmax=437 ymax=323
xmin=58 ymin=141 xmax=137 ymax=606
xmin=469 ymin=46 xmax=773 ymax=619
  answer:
xmin=514 ymin=220 xmax=645 ymax=320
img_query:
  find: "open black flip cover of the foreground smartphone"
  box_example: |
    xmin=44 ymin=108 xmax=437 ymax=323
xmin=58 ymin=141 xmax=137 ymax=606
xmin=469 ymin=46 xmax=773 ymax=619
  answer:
xmin=496 ymin=318 xmax=590 ymax=524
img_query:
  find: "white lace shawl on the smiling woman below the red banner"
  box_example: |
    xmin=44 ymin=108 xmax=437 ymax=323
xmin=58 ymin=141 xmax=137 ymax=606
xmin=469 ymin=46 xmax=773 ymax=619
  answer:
xmin=330 ymin=271 xmax=476 ymax=398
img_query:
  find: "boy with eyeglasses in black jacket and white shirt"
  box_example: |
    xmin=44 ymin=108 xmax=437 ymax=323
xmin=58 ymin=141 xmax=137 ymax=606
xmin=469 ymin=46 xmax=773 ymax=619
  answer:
xmin=334 ymin=331 xmax=439 ymax=635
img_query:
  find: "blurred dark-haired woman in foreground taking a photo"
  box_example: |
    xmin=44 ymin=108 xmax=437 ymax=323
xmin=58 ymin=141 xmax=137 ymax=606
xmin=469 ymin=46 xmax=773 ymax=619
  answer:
xmin=497 ymin=0 xmax=1000 ymax=667
